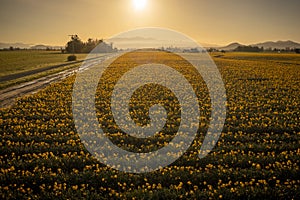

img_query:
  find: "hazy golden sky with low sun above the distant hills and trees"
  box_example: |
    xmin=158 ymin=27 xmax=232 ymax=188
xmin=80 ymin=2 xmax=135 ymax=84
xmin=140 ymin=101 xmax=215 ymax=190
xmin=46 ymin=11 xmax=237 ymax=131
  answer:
xmin=0 ymin=0 xmax=300 ymax=45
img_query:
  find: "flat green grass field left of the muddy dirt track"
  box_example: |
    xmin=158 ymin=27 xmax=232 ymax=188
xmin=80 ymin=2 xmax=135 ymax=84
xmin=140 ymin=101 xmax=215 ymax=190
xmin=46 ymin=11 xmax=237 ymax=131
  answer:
xmin=0 ymin=50 xmax=87 ymax=89
